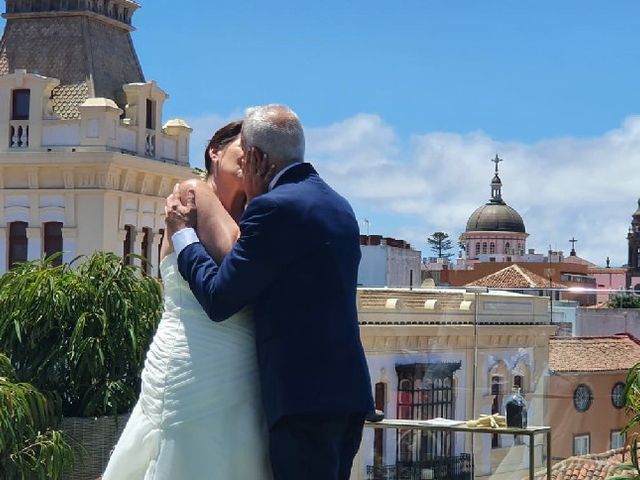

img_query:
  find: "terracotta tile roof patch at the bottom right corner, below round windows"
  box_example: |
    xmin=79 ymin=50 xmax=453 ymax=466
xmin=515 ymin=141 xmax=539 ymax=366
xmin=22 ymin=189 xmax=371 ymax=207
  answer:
xmin=523 ymin=447 xmax=629 ymax=480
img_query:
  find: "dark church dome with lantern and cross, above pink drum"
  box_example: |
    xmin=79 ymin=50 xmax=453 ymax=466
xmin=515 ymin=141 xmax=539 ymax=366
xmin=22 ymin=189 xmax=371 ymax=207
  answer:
xmin=466 ymin=155 xmax=526 ymax=233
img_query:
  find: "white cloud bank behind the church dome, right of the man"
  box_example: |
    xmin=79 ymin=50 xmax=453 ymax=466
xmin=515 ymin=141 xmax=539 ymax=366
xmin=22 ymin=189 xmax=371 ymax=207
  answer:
xmin=308 ymin=115 xmax=640 ymax=264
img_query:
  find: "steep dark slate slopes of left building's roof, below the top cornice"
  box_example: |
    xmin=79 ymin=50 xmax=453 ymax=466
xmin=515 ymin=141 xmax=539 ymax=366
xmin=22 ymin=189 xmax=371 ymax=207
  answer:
xmin=0 ymin=11 xmax=144 ymax=119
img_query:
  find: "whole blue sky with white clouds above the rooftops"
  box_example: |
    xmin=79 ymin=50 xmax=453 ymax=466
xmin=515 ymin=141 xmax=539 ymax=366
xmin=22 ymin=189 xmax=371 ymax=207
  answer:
xmin=5 ymin=0 xmax=640 ymax=265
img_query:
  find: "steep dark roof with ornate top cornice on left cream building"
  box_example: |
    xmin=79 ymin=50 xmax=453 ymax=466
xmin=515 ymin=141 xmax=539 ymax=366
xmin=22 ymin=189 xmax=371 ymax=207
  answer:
xmin=0 ymin=0 xmax=145 ymax=120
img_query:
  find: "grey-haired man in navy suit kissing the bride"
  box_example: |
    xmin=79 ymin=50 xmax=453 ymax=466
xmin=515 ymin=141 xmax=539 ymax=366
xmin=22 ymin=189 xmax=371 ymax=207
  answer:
xmin=167 ymin=105 xmax=373 ymax=480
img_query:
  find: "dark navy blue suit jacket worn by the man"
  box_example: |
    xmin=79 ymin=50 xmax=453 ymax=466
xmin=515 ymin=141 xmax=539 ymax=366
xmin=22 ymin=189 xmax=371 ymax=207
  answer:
xmin=178 ymin=163 xmax=373 ymax=425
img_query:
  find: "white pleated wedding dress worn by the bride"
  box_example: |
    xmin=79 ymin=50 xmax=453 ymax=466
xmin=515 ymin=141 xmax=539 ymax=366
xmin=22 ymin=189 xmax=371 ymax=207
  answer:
xmin=102 ymin=253 xmax=271 ymax=480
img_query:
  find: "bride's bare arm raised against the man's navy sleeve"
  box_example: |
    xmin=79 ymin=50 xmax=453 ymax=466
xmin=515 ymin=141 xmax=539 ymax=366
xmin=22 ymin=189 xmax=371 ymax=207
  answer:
xmin=180 ymin=179 xmax=240 ymax=265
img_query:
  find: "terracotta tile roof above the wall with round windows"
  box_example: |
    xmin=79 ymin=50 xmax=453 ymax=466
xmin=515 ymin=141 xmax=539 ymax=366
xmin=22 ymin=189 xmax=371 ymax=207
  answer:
xmin=549 ymin=334 xmax=640 ymax=372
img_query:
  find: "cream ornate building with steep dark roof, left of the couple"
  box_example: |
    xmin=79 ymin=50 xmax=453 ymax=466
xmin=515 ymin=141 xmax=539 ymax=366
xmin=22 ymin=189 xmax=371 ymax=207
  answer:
xmin=0 ymin=0 xmax=192 ymax=274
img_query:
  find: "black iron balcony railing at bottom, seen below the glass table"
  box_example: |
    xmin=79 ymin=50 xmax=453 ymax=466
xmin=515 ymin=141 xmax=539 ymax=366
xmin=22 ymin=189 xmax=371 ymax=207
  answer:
xmin=366 ymin=453 xmax=471 ymax=480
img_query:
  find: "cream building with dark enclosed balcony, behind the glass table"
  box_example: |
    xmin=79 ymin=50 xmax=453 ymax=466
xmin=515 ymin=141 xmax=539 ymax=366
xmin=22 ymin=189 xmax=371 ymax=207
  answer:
xmin=352 ymin=289 xmax=556 ymax=480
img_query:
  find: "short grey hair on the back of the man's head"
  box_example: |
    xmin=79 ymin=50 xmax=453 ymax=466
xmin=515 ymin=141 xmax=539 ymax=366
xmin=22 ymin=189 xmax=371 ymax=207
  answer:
xmin=241 ymin=104 xmax=304 ymax=165
